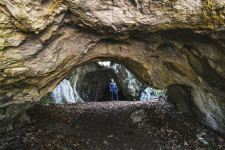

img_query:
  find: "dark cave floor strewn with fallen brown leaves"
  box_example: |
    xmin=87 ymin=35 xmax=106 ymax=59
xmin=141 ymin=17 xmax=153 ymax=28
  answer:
xmin=0 ymin=101 xmax=225 ymax=150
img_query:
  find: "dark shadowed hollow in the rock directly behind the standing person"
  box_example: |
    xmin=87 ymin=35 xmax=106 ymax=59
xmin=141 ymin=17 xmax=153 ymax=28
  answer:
xmin=76 ymin=69 xmax=128 ymax=102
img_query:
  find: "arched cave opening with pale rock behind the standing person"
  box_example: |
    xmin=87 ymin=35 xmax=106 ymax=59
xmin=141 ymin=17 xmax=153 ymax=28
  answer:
xmin=40 ymin=60 xmax=166 ymax=104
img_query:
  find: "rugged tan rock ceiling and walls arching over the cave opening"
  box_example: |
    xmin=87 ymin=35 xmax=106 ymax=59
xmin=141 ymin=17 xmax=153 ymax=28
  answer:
xmin=0 ymin=0 xmax=225 ymax=132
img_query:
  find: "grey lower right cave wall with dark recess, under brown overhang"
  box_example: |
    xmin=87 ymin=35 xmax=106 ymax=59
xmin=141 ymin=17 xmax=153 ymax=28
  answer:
xmin=167 ymin=85 xmax=225 ymax=132
